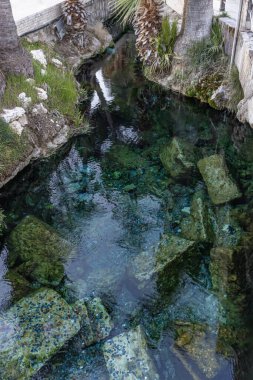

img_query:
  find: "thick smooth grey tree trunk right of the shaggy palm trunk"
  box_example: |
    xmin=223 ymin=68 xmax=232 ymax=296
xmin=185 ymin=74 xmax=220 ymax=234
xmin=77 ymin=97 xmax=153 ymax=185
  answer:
xmin=175 ymin=0 xmax=213 ymax=55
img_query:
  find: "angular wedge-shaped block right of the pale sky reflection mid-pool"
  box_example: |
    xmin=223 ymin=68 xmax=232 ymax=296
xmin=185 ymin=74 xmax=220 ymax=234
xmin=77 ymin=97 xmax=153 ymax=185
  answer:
xmin=132 ymin=235 xmax=195 ymax=286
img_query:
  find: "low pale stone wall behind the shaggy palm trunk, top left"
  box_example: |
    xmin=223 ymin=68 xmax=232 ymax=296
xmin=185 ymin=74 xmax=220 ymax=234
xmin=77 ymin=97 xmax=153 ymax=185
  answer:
xmin=16 ymin=0 xmax=110 ymax=36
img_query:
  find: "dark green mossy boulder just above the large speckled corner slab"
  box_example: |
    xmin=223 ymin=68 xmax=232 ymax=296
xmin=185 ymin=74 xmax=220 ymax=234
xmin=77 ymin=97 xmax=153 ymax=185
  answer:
xmin=8 ymin=216 xmax=71 ymax=286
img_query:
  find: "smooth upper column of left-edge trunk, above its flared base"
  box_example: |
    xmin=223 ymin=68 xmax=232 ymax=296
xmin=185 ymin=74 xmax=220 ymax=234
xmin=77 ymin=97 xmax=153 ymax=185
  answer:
xmin=0 ymin=0 xmax=19 ymax=50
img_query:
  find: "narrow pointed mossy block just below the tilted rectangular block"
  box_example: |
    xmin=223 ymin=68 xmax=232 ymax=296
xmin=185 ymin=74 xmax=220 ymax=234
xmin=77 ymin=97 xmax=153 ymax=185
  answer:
xmin=181 ymin=192 xmax=214 ymax=242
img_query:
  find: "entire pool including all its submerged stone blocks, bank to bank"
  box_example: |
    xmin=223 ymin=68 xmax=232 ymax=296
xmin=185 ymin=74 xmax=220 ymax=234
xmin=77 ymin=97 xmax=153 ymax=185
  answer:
xmin=0 ymin=38 xmax=253 ymax=380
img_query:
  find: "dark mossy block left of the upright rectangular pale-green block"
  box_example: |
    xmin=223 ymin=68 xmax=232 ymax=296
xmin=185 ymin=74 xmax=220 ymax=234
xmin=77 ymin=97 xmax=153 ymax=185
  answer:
xmin=160 ymin=137 xmax=197 ymax=178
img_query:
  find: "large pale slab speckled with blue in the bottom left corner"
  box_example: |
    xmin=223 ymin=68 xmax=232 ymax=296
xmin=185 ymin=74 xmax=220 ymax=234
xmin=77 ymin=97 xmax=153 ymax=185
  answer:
xmin=0 ymin=288 xmax=80 ymax=380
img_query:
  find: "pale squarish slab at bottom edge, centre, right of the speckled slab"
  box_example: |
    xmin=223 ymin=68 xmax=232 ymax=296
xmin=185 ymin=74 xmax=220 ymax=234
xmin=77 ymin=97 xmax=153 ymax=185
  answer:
xmin=103 ymin=326 xmax=159 ymax=380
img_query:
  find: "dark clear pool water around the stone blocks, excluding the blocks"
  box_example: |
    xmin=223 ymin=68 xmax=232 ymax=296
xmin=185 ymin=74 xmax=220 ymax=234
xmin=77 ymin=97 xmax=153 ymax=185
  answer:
xmin=0 ymin=35 xmax=253 ymax=380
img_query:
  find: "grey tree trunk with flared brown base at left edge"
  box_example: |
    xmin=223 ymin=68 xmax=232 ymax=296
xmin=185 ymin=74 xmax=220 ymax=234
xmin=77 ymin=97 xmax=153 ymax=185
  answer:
xmin=0 ymin=0 xmax=33 ymax=81
